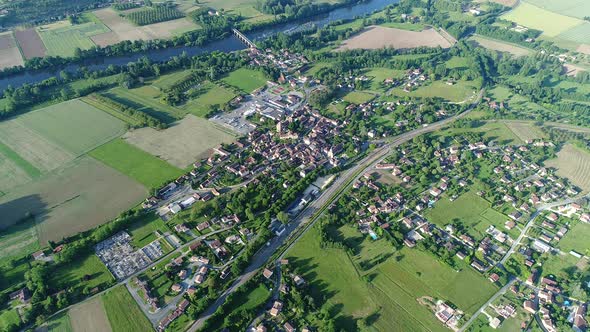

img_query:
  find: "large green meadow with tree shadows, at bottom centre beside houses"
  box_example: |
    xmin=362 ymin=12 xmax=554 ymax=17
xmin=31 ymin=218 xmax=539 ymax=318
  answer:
xmin=288 ymin=226 xmax=496 ymax=331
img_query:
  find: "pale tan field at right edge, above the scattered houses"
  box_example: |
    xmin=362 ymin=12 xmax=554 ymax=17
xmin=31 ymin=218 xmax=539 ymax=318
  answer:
xmin=545 ymin=144 xmax=590 ymax=193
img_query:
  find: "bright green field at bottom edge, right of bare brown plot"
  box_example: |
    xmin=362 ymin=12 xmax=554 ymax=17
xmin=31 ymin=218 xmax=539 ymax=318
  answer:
xmin=102 ymin=286 xmax=153 ymax=332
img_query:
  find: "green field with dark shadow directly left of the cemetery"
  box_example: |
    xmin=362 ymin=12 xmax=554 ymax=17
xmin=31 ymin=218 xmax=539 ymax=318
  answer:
xmin=49 ymin=254 xmax=114 ymax=293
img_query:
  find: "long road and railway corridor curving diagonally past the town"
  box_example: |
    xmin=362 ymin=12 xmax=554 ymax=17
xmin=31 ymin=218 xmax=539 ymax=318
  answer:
xmin=188 ymin=89 xmax=484 ymax=332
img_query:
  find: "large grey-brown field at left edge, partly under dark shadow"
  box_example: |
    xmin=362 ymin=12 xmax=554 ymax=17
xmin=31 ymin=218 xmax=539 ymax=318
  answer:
xmin=0 ymin=158 xmax=147 ymax=245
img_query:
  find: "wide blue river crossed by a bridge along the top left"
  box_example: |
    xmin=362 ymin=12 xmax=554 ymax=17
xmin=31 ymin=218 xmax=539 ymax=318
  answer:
xmin=0 ymin=0 xmax=399 ymax=91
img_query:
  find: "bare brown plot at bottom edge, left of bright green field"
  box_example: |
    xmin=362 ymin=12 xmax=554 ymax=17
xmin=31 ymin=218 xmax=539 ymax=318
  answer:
xmin=69 ymin=297 xmax=112 ymax=332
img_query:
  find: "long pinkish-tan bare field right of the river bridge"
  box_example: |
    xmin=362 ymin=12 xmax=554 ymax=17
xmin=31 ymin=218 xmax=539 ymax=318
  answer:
xmin=338 ymin=26 xmax=452 ymax=50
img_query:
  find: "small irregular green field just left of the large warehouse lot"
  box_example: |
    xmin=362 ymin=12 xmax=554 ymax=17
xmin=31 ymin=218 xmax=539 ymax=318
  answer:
xmin=182 ymin=82 xmax=236 ymax=117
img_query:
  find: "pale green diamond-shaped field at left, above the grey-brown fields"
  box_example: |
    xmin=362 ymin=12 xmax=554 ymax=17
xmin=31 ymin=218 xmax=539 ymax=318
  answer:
xmin=17 ymin=99 xmax=125 ymax=155
